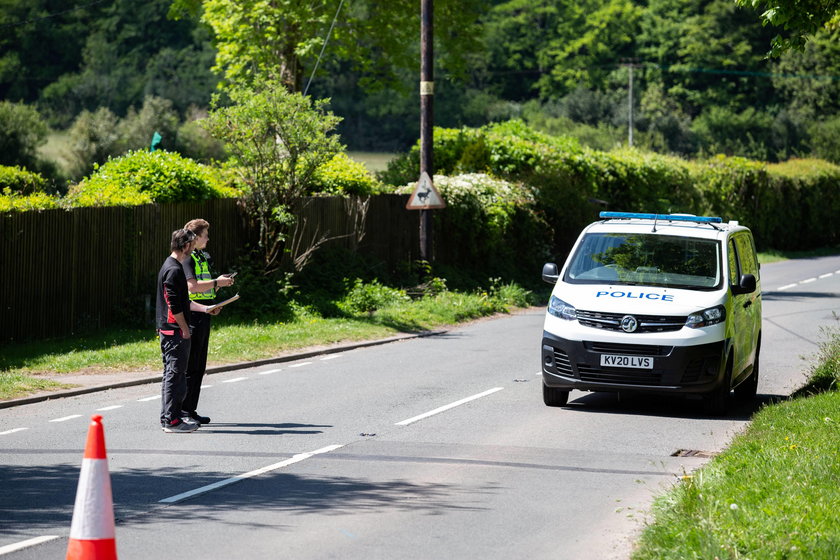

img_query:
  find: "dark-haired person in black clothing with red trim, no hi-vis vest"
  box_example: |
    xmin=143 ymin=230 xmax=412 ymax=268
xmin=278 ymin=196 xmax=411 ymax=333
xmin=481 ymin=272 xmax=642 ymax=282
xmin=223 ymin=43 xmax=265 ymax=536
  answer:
xmin=155 ymin=229 xmax=218 ymax=433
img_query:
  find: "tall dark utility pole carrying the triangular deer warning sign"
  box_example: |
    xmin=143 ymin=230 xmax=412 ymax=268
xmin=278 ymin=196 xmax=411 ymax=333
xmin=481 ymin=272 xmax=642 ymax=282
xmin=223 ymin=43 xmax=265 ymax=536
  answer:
xmin=420 ymin=0 xmax=435 ymax=261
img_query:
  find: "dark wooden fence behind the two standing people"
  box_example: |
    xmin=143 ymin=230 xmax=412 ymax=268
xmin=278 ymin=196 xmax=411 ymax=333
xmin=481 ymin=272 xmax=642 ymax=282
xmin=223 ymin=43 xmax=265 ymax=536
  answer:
xmin=0 ymin=195 xmax=419 ymax=341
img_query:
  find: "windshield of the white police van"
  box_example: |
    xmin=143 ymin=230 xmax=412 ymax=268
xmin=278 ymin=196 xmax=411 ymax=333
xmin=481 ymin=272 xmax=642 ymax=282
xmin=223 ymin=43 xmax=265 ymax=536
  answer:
xmin=564 ymin=233 xmax=722 ymax=290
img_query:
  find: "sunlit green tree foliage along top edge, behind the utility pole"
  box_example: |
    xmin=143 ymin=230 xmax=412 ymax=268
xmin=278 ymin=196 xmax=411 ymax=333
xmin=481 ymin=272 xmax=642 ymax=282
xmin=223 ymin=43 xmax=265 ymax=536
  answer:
xmin=184 ymin=0 xmax=488 ymax=91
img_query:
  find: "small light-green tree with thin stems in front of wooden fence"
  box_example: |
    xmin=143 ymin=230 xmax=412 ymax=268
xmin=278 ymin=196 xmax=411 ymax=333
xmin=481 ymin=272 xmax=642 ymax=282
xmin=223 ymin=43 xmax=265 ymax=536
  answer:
xmin=207 ymin=80 xmax=343 ymax=274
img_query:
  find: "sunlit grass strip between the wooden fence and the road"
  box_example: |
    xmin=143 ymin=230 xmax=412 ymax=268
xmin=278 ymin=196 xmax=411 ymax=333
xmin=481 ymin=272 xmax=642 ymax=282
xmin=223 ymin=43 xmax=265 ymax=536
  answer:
xmin=0 ymin=285 xmax=529 ymax=399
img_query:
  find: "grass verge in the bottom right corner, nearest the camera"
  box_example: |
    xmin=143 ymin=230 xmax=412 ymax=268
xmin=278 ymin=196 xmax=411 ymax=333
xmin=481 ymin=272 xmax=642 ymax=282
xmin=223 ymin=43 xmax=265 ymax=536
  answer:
xmin=632 ymin=331 xmax=840 ymax=560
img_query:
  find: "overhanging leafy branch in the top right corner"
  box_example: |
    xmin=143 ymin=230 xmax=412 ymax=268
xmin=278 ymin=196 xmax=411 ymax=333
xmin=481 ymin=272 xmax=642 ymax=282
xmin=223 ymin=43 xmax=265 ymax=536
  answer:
xmin=735 ymin=0 xmax=840 ymax=57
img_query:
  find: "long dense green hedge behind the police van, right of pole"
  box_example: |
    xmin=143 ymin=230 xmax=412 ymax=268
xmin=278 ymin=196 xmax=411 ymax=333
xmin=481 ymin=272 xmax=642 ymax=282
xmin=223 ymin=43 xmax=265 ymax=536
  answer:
xmin=382 ymin=121 xmax=840 ymax=252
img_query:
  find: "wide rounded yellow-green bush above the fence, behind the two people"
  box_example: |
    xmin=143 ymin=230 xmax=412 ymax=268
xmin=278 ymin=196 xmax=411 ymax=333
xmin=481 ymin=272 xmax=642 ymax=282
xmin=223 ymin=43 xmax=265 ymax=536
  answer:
xmin=65 ymin=150 xmax=236 ymax=206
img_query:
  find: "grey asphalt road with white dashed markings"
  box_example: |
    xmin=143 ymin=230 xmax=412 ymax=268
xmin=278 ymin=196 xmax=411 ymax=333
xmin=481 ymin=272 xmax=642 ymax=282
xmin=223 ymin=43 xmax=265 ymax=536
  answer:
xmin=0 ymin=257 xmax=840 ymax=560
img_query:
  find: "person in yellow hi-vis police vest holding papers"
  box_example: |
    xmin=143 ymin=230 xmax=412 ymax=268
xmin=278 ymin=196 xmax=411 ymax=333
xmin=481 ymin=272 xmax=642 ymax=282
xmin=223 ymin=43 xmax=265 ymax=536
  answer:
xmin=182 ymin=218 xmax=233 ymax=424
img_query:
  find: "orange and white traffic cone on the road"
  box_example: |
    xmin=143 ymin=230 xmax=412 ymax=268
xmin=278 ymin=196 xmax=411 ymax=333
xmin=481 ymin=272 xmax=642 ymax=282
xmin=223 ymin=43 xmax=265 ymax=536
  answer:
xmin=67 ymin=414 xmax=117 ymax=560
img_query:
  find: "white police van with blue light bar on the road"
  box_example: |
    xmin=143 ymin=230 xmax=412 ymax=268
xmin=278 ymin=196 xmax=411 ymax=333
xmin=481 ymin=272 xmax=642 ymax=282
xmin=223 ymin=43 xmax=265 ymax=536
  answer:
xmin=542 ymin=212 xmax=761 ymax=414
